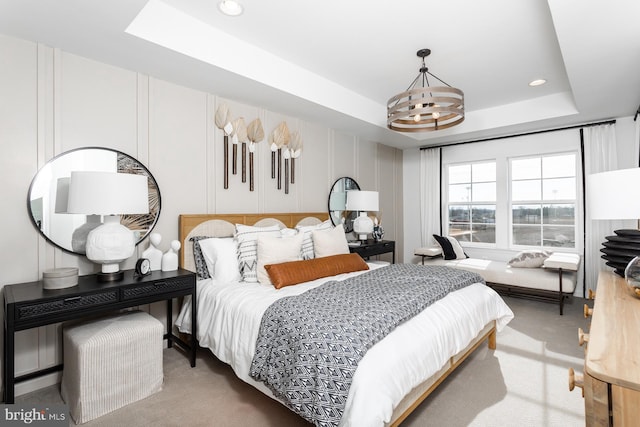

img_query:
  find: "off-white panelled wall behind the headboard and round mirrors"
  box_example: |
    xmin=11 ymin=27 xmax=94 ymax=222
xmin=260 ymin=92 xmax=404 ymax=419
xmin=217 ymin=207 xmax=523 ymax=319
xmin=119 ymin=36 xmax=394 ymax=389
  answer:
xmin=0 ymin=35 xmax=402 ymax=394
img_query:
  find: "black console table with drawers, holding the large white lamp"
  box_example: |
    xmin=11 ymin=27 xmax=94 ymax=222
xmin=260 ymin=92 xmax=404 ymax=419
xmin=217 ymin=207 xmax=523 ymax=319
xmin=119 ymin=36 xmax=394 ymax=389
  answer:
xmin=3 ymin=269 xmax=198 ymax=403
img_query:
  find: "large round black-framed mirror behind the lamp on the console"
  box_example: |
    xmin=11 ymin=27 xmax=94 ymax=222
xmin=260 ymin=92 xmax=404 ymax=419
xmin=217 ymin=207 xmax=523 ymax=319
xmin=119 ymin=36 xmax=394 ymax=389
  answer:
xmin=27 ymin=147 xmax=160 ymax=255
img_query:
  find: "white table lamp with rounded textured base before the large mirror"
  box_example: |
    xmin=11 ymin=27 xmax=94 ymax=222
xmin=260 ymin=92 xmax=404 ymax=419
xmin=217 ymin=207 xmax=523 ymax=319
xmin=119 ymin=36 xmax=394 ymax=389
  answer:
xmin=67 ymin=171 xmax=149 ymax=281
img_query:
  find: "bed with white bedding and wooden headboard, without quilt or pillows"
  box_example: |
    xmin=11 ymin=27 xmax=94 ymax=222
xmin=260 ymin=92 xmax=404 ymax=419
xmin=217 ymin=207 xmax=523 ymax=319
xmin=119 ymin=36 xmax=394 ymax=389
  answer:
xmin=176 ymin=212 xmax=513 ymax=426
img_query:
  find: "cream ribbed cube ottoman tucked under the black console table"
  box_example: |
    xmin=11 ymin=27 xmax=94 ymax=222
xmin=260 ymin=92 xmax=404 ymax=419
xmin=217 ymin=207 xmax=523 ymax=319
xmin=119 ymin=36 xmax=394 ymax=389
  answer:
xmin=61 ymin=311 xmax=164 ymax=424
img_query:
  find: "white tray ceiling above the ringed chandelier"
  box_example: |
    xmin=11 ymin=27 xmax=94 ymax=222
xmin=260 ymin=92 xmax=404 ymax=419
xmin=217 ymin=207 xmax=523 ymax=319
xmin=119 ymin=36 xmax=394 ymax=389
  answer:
xmin=0 ymin=0 xmax=640 ymax=148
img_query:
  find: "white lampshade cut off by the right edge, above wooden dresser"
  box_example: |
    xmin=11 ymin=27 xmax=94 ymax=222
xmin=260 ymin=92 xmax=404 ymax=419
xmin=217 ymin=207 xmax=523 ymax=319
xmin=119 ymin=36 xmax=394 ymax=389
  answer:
xmin=587 ymin=168 xmax=640 ymax=220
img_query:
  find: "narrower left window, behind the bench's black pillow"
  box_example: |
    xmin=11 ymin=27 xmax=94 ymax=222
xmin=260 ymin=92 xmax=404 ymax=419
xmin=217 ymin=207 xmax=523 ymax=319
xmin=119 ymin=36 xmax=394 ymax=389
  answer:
xmin=448 ymin=162 xmax=496 ymax=243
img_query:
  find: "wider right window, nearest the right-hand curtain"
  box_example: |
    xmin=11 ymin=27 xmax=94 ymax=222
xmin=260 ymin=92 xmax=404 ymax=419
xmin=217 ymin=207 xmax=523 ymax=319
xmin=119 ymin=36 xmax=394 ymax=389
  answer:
xmin=510 ymin=153 xmax=576 ymax=248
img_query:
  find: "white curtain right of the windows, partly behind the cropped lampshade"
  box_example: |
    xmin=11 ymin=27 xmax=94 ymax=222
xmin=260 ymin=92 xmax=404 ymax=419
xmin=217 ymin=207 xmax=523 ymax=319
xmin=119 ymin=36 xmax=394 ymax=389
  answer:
xmin=583 ymin=124 xmax=624 ymax=296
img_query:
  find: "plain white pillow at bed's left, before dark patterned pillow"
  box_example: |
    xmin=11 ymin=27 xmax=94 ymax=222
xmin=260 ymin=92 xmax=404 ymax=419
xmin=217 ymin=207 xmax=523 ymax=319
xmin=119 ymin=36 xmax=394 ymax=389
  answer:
xmin=199 ymin=237 xmax=240 ymax=283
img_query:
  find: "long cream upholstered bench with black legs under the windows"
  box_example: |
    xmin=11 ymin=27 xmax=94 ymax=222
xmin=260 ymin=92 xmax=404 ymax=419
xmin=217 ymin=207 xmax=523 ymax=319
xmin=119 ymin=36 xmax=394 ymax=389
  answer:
xmin=414 ymin=247 xmax=580 ymax=314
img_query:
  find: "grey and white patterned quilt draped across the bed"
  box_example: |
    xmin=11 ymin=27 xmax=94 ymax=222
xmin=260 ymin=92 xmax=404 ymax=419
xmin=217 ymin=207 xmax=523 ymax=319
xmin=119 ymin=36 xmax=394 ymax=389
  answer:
xmin=250 ymin=264 xmax=484 ymax=426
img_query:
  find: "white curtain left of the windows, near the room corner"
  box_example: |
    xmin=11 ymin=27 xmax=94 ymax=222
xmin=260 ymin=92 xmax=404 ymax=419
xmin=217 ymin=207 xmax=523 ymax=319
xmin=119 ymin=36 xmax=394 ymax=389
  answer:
xmin=420 ymin=147 xmax=441 ymax=247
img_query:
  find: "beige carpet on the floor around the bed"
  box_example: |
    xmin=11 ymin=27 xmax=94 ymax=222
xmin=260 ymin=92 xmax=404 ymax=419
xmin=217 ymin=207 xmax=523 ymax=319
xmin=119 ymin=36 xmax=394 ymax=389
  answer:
xmin=16 ymin=298 xmax=588 ymax=427
